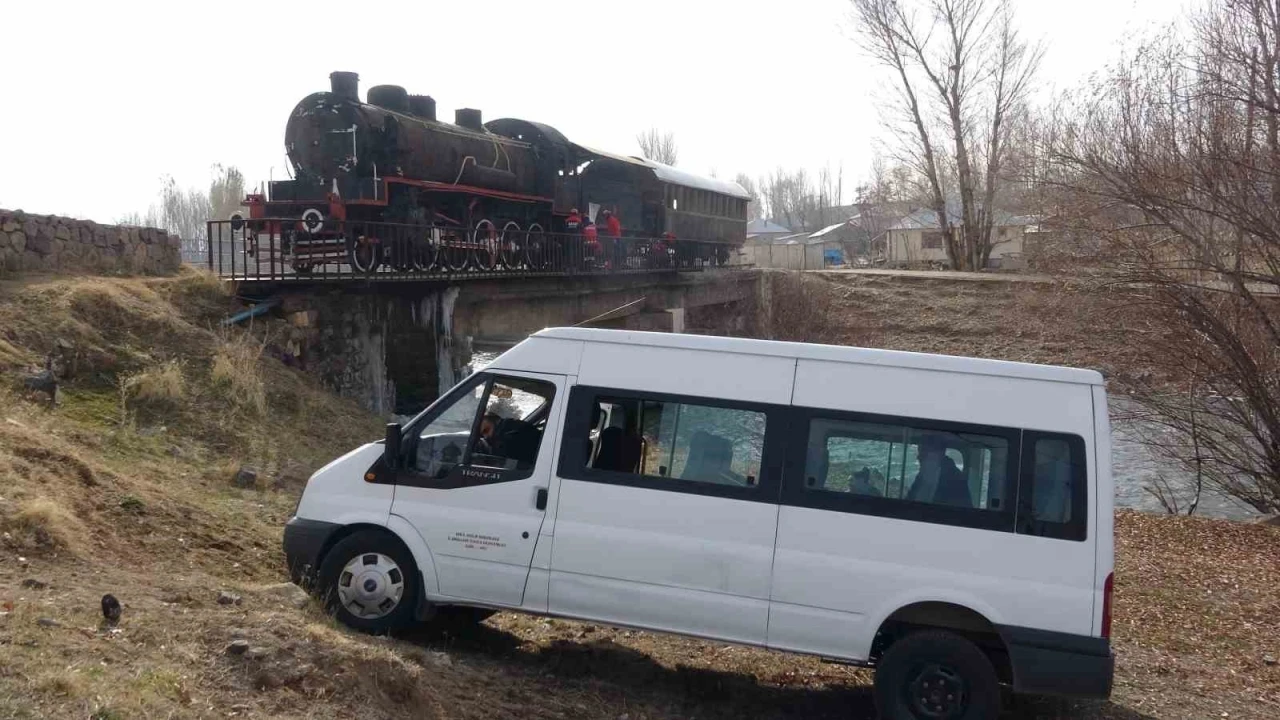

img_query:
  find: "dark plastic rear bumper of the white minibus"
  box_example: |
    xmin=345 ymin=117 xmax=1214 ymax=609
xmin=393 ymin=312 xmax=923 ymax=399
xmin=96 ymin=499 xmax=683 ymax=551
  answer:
xmin=1001 ymin=625 xmax=1115 ymax=698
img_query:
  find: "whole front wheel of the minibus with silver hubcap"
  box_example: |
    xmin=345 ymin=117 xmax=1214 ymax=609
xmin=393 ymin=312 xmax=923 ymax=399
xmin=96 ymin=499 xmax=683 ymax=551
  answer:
xmin=320 ymin=530 xmax=419 ymax=633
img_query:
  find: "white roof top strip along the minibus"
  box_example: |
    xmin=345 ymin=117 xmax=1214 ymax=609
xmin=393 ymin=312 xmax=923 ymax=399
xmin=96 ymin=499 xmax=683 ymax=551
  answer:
xmin=530 ymin=328 xmax=1103 ymax=386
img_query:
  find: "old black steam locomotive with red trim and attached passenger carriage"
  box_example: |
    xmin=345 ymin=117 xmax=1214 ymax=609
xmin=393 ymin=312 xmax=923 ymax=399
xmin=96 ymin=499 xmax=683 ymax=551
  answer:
xmin=247 ymin=72 xmax=749 ymax=272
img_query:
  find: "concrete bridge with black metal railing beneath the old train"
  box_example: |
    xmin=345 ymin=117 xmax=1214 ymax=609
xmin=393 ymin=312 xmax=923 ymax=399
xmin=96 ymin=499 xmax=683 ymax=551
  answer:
xmin=202 ymin=219 xmax=763 ymax=415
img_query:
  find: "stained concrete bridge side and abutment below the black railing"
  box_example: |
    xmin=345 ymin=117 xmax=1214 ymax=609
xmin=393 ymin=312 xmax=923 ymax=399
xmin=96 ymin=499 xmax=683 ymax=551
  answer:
xmin=257 ymin=270 xmax=762 ymax=416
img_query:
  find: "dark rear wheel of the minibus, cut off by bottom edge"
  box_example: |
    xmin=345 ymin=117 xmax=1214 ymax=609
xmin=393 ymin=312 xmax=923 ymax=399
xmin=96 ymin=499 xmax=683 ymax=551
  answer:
xmin=876 ymin=630 xmax=1000 ymax=720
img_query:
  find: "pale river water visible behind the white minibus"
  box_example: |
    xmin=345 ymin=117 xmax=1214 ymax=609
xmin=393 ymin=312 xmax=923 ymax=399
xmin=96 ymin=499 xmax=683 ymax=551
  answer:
xmin=471 ymin=346 xmax=1257 ymax=520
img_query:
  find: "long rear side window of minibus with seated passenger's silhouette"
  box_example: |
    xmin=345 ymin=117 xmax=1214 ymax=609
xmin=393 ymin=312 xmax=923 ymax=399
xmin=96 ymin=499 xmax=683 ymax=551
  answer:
xmin=804 ymin=419 xmax=1009 ymax=511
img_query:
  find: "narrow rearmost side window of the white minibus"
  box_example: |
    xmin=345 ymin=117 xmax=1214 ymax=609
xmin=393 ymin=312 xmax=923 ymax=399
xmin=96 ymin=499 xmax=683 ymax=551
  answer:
xmin=1018 ymin=432 xmax=1088 ymax=541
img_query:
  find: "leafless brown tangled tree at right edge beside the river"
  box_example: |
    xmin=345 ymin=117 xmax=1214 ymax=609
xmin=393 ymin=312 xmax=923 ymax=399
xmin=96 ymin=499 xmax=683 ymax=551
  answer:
xmin=1047 ymin=0 xmax=1280 ymax=512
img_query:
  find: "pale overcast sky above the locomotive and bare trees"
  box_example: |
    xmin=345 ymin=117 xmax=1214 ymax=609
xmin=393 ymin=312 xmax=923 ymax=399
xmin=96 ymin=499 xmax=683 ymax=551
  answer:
xmin=0 ymin=0 xmax=1184 ymax=222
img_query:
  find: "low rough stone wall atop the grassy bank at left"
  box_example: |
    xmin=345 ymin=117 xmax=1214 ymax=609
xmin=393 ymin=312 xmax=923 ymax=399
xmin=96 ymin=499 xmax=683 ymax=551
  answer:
xmin=0 ymin=209 xmax=182 ymax=275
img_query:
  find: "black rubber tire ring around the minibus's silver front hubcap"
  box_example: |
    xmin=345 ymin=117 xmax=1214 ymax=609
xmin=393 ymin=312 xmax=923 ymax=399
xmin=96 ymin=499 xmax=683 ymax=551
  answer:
xmin=319 ymin=530 xmax=421 ymax=633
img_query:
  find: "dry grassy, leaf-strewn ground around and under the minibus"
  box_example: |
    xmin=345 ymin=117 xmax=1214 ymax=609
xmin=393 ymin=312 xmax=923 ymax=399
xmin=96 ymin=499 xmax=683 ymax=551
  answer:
xmin=0 ymin=274 xmax=1280 ymax=719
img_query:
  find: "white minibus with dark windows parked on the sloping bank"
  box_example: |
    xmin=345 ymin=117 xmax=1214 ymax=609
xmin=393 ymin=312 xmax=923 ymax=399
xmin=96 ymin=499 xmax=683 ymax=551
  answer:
xmin=284 ymin=328 xmax=1114 ymax=719
